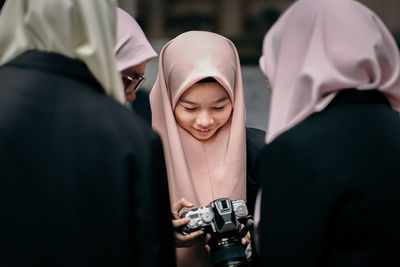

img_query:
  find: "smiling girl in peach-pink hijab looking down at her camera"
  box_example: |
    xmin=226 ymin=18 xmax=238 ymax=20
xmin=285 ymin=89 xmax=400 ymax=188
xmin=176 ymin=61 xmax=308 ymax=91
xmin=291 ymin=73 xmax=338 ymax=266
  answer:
xmin=150 ymin=31 xmax=264 ymax=267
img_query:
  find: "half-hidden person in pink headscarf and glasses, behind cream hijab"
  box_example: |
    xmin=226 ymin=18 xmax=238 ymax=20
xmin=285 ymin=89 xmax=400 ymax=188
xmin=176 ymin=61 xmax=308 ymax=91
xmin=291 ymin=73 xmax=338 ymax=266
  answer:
xmin=114 ymin=8 xmax=157 ymax=101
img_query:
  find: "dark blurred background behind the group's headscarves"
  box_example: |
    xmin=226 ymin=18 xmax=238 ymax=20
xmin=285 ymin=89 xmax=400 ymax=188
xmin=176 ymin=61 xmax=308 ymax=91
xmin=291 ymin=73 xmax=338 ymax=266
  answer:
xmin=118 ymin=0 xmax=400 ymax=130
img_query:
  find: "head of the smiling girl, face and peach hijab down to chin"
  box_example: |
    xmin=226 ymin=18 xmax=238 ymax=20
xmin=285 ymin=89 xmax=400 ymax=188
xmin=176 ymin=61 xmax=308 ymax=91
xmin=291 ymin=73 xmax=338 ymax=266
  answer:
xmin=151 ymin=31 xmax=245 ymax=141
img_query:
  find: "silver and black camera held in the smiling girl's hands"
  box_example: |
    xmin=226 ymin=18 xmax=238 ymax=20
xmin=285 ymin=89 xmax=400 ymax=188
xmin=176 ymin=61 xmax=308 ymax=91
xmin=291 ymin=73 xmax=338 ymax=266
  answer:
xmin=181 ymin=198 xmax=253 ymax=267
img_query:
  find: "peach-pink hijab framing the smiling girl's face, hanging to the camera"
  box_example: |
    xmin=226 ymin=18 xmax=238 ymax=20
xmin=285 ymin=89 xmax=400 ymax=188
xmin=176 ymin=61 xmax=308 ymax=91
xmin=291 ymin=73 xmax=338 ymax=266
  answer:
xmin=150 ymin=31 xmax=246 ymax=267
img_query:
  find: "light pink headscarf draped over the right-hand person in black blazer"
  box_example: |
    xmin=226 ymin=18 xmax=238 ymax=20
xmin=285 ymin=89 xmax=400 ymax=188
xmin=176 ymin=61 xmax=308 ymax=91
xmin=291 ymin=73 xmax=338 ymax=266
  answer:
xmin=260 ymin=0 xmax=400 ymax=143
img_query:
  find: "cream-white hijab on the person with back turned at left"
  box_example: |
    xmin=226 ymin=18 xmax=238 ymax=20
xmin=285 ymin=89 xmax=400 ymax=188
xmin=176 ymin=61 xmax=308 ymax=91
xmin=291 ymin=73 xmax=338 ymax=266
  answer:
xmin=0 ymin=0 xmax=125 ymax=103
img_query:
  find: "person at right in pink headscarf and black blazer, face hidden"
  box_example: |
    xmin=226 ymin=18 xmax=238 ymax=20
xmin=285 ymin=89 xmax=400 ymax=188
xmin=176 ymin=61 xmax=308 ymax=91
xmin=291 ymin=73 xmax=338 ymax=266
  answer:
xmin=258 ymin=0 xmax=400 ymax=267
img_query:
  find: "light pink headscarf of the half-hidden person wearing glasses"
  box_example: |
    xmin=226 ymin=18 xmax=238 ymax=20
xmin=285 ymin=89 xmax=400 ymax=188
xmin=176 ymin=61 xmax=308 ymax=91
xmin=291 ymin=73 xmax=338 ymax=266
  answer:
xmin=114 ymin=8 xmax=157 ymax=72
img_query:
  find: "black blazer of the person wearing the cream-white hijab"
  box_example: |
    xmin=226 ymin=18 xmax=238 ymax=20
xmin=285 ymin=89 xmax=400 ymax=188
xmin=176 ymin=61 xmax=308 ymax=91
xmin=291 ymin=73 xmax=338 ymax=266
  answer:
xmin=0 ymin=51 xmax=175 ymax=266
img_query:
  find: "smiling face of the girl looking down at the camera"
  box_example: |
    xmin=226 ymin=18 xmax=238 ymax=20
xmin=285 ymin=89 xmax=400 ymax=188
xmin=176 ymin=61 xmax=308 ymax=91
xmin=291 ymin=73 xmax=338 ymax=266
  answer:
xmin=174 ymin=82 xmax=233 ymax=141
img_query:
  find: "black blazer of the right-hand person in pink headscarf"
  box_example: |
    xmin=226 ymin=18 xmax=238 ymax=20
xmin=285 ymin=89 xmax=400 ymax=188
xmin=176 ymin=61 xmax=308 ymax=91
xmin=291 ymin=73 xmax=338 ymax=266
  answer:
xmin=259 ymin=90 xmax=400 ymax=267
